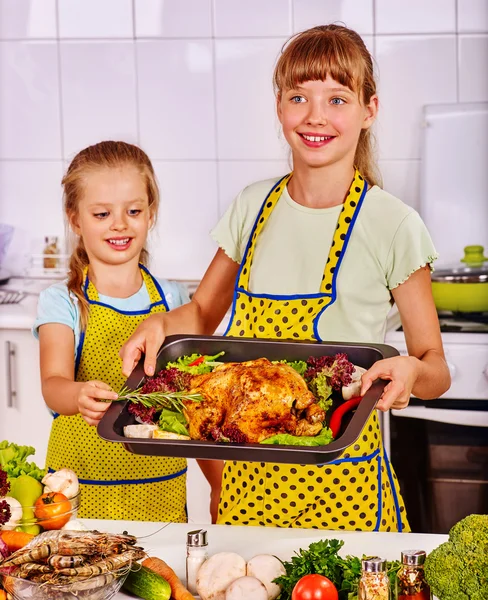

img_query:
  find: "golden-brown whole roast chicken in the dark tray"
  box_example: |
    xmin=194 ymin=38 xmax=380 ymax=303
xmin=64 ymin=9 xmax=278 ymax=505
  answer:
xmin=184 ymin=358 xmax=325 ymax=442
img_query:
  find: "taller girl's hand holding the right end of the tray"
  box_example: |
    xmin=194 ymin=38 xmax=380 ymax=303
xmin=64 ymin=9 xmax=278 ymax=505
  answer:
xmin=361 ymin=356 xmax=420 ymax=412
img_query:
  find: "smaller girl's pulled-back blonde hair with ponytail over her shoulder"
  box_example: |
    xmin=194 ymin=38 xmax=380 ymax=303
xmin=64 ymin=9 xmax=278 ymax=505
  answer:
xmin=62 ymin=141 xmax=159 ymax=330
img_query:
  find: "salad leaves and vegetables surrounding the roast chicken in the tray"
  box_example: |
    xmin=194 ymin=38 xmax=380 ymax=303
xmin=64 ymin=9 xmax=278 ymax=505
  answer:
xmin=119 ymin=352 xmax=364 ymax=446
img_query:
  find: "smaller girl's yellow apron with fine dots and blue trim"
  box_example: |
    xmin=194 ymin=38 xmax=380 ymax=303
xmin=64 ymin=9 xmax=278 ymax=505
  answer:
xmin=46 ymin=265 xmax=187 ymax=522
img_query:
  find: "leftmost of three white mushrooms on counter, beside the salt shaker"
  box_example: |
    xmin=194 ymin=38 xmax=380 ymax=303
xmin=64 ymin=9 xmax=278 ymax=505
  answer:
xmin=197 ymin=552 xmax=246 ymax=600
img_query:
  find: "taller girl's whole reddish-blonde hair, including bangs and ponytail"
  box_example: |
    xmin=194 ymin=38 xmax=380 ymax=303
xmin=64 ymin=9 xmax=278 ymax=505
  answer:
xmin=273 ymin=25 xmax=381 ymax=185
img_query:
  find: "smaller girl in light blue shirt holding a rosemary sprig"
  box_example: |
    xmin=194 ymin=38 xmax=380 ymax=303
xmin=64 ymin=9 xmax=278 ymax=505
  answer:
xmin=34 ymin=142 xmax=203 ymax=521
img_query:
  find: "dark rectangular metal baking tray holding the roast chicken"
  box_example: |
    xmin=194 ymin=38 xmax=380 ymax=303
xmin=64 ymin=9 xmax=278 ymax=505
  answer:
xmin=98 ymin=335 xmax=398 ymax=465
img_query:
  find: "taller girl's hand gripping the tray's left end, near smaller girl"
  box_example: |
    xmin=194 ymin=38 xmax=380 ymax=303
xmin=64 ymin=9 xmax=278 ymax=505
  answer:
xmin=119 ymin=313 xmax=166 ymax=377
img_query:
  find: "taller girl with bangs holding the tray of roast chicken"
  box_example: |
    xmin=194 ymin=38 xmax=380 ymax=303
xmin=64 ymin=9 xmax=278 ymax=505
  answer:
xmin=123 ymin=25 xmax=450 ymax=531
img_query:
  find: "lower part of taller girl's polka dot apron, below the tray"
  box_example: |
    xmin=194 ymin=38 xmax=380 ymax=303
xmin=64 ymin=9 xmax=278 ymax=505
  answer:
xmin=217 ymin=412 xmax=410 ymax=531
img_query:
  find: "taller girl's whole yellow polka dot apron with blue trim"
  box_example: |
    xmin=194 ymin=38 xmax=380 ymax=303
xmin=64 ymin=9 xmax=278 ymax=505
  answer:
xmin=217 ymin=171 xmax=409 ymax=531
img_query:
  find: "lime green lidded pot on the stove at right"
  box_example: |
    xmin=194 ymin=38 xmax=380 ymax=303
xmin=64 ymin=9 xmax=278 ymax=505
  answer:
xmin=432 ymin=246 xmax=488 ymax=313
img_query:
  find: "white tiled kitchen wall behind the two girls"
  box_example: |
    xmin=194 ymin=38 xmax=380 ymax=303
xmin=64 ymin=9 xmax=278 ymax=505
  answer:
xmin=0 ymin=0 xmax=488 ymax=278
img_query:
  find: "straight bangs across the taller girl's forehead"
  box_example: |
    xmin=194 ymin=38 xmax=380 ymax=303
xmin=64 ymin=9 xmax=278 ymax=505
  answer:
xmin=275 ymin=40 xmax=364 ymax=92
